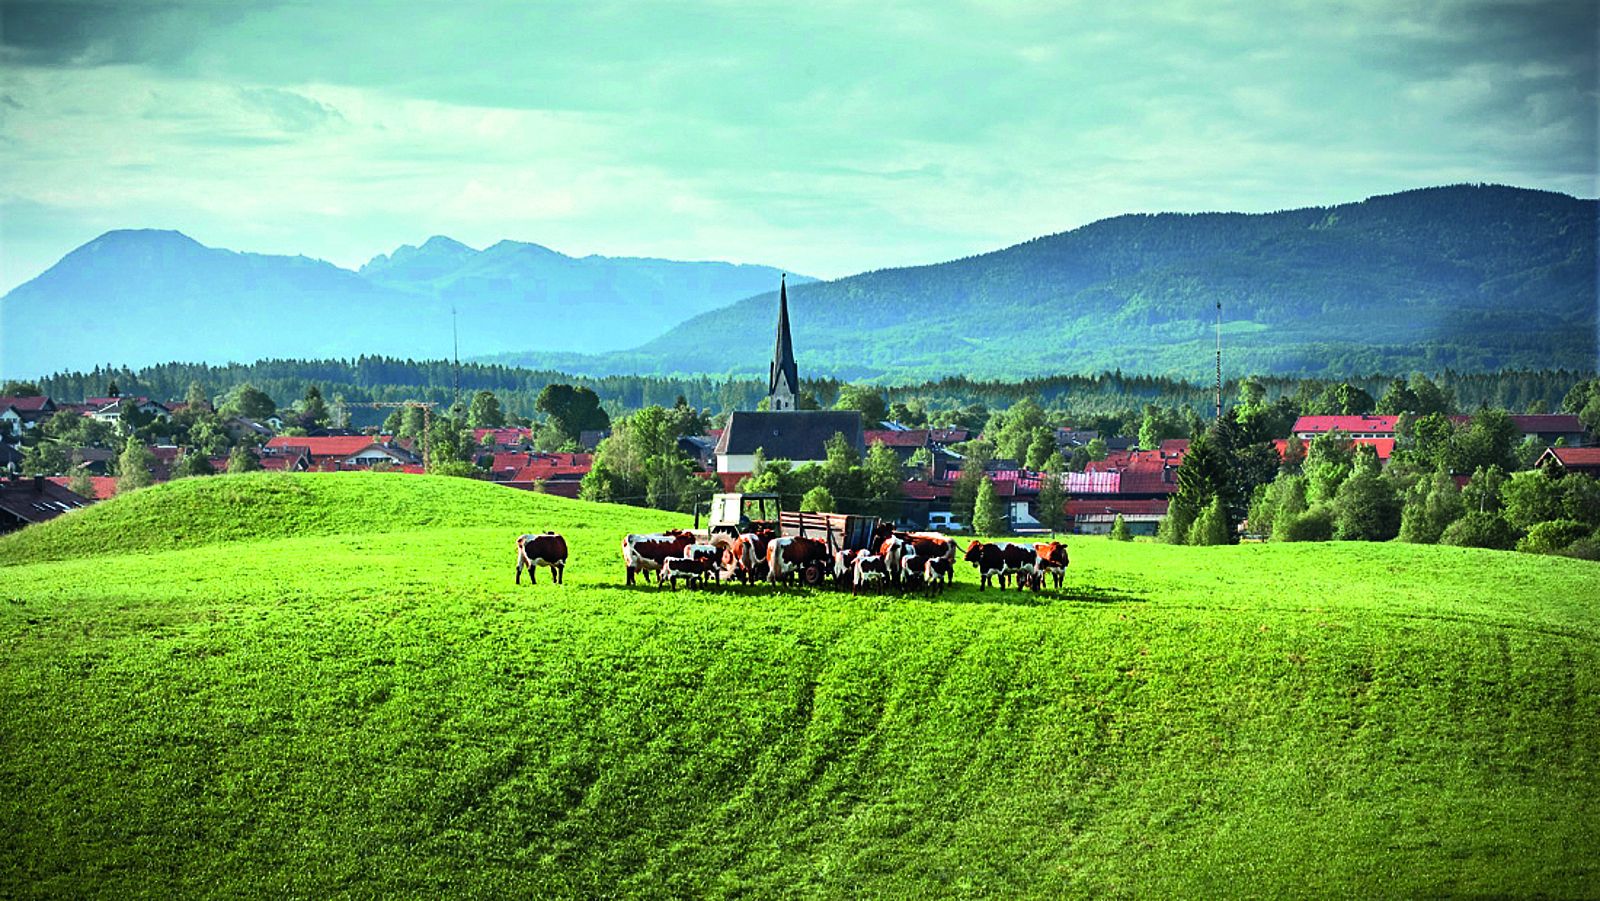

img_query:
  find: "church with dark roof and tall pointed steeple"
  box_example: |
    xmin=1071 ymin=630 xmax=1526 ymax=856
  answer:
xmin=717 ymin=278 xmax=866 ymax=491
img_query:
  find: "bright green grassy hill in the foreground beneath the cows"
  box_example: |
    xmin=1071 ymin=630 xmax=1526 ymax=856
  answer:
xmin=0 ymin=474 xmax=1600 ymax=898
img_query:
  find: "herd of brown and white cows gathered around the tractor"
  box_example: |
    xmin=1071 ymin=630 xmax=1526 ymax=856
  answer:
xmin=515 ymin=525 xmax=1067 ymax=594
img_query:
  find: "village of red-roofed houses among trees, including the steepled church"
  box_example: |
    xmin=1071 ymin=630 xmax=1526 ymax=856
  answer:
xmin=0 ymin=280 xmax=1600 ymax=536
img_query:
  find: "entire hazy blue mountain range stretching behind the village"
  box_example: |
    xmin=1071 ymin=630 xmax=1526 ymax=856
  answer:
xmin=0 ymin=186 xmax=1597 ymax=381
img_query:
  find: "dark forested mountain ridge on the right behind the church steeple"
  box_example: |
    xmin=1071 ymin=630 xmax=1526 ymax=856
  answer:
xmin=501 ymin=186 xmax=1597 ymax=381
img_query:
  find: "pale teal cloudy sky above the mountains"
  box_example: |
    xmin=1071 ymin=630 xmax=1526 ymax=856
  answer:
xmin=0 ymin=0 xmax=1600 ymax=291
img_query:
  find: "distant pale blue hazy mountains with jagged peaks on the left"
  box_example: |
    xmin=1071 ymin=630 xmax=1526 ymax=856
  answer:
xmin=0 ymin=229 xmax=810 ymax=376
